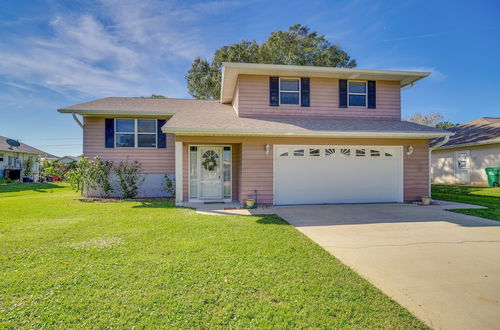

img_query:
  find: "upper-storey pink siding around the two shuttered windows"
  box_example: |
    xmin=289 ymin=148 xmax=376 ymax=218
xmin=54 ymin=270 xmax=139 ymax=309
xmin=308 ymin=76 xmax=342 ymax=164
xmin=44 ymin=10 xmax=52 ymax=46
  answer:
xmin=233 ymin=75 xmax=401 ymax=120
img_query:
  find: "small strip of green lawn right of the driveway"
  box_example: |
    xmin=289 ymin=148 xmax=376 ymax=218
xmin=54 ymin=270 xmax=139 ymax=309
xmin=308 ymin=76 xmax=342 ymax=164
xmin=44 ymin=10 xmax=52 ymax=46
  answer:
xmin=432 ymin=185 xmax=500 ymax=221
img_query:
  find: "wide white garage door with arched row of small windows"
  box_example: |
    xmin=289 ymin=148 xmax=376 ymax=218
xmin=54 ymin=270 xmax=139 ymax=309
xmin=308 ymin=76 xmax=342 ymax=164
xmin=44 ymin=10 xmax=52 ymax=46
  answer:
xmin=273 ymin=145 xmax=403 ymax=205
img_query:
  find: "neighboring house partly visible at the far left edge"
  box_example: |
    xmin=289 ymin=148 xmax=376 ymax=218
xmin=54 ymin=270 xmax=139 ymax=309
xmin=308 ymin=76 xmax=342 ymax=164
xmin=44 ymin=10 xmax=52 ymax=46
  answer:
xmin=0 ymin=136 xmax=57 ymax=181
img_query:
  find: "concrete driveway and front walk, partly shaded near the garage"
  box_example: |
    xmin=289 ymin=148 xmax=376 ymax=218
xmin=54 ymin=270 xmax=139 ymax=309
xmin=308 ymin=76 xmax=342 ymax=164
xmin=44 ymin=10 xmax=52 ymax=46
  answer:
xmin=190 ymin=203 xmax=500 ymax=329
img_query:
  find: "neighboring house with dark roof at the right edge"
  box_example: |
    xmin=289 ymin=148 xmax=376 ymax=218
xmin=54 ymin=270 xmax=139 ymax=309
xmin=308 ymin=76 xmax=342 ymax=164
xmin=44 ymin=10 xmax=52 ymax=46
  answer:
xmin=431 ymin=117 xmax=500 ymax=186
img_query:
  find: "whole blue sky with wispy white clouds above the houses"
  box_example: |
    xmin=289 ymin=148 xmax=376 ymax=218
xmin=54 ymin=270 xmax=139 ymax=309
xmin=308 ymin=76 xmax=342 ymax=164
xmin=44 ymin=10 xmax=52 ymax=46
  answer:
xmin=0 ymin=0 xmax=500 ymax=155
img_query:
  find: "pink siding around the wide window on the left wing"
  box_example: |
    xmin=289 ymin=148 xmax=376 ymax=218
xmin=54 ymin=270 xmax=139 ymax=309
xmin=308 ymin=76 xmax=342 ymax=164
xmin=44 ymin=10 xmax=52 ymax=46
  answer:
xmin=83 ymin=117 xmax=175 ymax=174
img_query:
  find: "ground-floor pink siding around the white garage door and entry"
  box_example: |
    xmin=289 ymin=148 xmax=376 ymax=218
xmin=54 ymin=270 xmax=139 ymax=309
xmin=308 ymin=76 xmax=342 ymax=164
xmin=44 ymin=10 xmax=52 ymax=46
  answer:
xmin=177 ymin=136 xmax=429 ymax=203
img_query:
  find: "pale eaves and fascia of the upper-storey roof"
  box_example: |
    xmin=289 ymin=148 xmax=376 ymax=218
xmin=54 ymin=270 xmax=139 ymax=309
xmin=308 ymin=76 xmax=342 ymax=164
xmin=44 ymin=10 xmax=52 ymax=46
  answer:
xmin=220 ymin=62 xmax=430 ymax=103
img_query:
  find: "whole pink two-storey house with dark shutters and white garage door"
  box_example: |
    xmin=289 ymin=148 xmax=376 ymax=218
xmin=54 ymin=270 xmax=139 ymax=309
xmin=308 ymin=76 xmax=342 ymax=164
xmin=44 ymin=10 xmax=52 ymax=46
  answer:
xmin=59 ymin=63 xmax=452 ymax=205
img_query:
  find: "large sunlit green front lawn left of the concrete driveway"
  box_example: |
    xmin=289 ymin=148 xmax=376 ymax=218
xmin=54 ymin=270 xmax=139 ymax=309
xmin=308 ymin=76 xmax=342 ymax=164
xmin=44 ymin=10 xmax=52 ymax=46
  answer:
xmin=0 ymin=184 xmax=425 ymax=329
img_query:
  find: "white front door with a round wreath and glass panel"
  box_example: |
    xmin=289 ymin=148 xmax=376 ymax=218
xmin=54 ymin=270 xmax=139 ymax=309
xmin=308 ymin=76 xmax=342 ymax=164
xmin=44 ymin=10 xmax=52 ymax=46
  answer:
xmin=198 ymin=147 xmax=223 ymax=199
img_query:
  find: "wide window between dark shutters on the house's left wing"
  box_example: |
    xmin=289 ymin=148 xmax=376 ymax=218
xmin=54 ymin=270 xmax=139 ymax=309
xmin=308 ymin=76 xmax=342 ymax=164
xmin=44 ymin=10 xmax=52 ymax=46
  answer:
xmin=115 ymin=119 xmax=156 ymax=148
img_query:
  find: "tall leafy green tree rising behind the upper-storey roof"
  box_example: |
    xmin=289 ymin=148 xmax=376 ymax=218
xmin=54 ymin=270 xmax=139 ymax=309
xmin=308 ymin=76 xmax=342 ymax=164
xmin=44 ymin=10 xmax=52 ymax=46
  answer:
xmin=186 ymin=24 xmax=356 ymax=100
